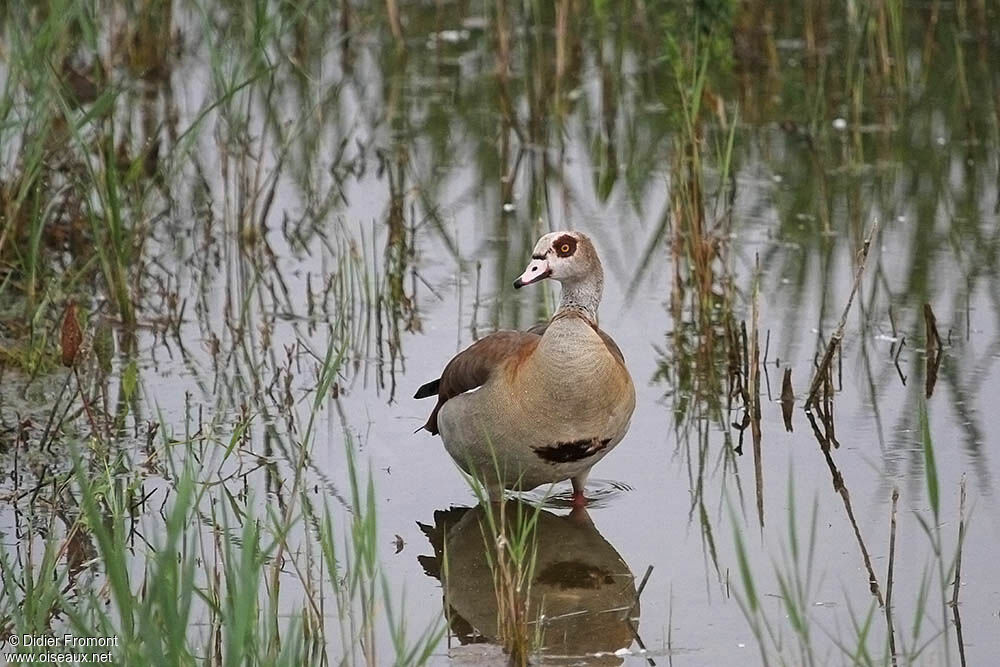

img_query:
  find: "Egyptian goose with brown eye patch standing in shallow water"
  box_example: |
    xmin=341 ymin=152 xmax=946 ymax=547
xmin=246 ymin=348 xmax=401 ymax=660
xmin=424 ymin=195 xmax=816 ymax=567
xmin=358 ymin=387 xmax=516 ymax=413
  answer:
xmin=414 ymin=232 xmax=635 ymax=505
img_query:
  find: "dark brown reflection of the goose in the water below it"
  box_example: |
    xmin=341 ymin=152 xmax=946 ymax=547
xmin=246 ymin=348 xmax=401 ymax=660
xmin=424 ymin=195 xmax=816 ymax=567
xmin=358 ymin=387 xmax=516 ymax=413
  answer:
xmin=418 ymin=500 xmax=639 ymax=664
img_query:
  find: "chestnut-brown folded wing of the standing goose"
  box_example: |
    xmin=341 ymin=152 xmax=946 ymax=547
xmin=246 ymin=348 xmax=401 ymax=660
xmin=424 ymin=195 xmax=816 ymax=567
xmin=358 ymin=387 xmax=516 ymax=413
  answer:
xmin=418 ymin=331 xmax=541 ymax=435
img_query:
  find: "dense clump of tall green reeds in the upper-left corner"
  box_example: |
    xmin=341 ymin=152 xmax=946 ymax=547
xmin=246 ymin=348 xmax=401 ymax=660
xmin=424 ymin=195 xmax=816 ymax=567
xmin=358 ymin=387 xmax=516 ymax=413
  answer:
xmin=0 ymin=0 xmax=300 ymax=360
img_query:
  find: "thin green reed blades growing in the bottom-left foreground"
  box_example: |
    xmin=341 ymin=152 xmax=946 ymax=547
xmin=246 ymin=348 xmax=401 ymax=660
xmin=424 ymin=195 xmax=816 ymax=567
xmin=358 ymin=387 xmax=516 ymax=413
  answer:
xmin=0 ymin=439 xmax=443 ymax=666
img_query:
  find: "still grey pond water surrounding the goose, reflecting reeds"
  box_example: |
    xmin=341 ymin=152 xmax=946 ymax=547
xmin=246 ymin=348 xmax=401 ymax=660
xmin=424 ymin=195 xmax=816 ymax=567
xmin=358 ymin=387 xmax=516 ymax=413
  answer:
xmin=0 ymin=3 xmax=1000 ymax=665
